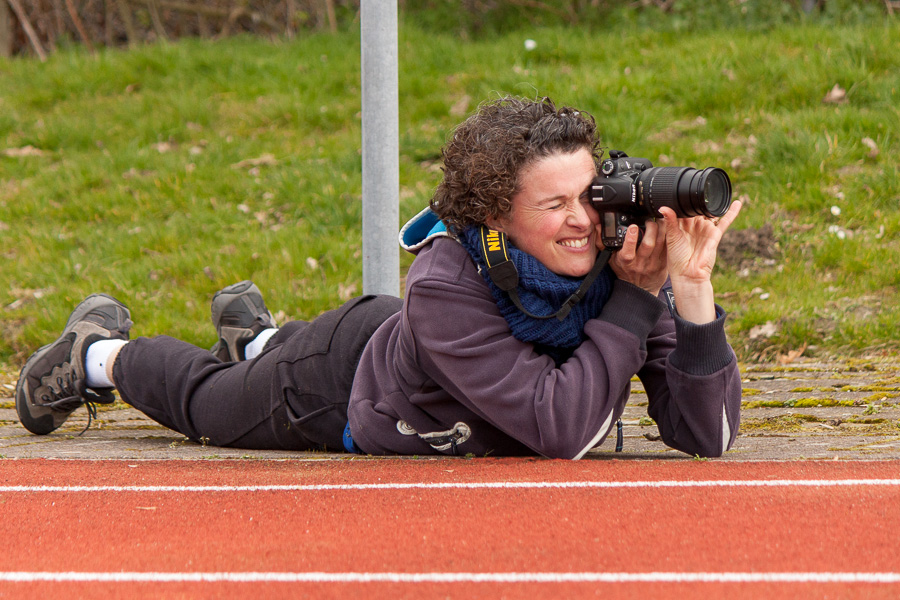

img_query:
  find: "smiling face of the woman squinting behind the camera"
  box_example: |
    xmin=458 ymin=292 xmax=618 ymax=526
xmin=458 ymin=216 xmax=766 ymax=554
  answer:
xmin=488 ymin=149 xmax=600 ymax=277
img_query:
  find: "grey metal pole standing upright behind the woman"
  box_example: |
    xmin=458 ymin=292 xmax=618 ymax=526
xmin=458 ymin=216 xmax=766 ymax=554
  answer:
xmin=360 ymin=0 xmax=400 ymax=296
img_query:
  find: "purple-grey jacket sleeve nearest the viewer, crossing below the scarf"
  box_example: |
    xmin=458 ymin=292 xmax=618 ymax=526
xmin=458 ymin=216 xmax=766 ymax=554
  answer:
xmin=402 ymin=268 xmax=665 ymax=459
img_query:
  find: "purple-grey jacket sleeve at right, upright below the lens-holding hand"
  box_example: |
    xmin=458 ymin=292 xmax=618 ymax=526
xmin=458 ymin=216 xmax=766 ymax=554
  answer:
xmin=638 ymin=290 xmax=741 ymax=457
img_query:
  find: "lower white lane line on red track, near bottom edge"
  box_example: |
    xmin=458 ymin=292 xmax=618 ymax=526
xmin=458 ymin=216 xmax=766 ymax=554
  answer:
xmin=0 ymin=571 xmax=900 ymax=583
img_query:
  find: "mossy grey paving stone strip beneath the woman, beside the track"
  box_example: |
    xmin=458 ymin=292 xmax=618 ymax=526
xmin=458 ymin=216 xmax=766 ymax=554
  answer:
xmin=0 ymin=357 xmax=900 ymax=461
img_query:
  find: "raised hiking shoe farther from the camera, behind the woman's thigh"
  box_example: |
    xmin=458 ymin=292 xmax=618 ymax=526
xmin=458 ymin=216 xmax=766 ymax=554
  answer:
xmin=210 ymin=281 xmax=278 ymax=362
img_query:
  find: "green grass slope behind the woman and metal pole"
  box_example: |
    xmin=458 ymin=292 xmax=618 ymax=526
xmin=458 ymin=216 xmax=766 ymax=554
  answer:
xmin=0 ymin=19 xmax=900 ymax=364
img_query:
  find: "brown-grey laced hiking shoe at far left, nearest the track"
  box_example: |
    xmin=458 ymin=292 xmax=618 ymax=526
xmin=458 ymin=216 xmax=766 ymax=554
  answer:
xmin=16 ymin=294 xmax=132 ymax=435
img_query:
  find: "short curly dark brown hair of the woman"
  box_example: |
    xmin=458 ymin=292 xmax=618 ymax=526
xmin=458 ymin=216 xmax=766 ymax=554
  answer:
xmin=431 ymin=96 xmax=603 ymax=231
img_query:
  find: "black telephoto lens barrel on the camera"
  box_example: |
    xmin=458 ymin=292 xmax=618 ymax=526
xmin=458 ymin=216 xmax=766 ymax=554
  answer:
xmin=638 ymin=167 xmax=731 ymax=217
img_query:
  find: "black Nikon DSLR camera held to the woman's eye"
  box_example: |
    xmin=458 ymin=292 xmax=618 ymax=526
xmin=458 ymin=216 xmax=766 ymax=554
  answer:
xmin=590 ymin=150 xmax=731 ymax=250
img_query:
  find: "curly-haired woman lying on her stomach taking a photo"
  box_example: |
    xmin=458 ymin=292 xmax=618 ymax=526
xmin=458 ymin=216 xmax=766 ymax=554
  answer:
xmin=16 ymin=97 xmax=741 ymax=459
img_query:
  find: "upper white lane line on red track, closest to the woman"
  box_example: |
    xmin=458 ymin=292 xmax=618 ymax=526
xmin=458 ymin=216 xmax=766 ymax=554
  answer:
xmin=0 ymin=479 xmax=900 ymax=493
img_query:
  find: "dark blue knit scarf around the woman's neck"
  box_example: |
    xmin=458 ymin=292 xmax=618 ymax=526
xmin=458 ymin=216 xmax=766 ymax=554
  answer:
xmin=459 ymin=227 xmax=615 ymax=364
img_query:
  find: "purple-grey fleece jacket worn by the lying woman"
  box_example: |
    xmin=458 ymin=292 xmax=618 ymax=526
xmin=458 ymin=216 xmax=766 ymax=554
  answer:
xmin=349 ymin=237 xmax=741 ymax=459
